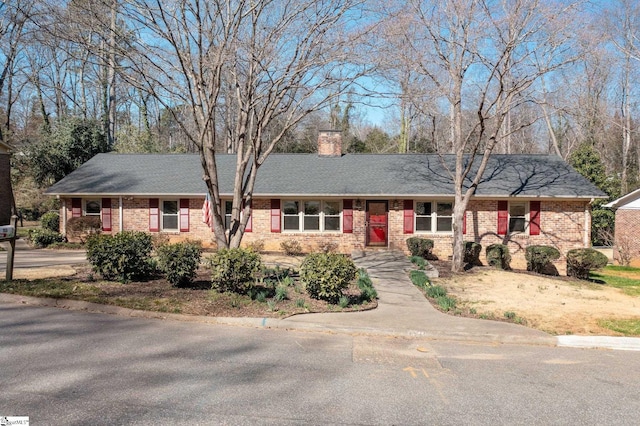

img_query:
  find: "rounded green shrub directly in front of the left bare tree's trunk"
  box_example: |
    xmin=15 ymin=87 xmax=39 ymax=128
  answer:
xmin=207 ymin=248 xmax=262 ymax=294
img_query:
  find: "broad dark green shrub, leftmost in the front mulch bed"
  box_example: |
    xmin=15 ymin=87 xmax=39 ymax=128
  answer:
xmin=87 ymin=231 xmax=156 ymax=283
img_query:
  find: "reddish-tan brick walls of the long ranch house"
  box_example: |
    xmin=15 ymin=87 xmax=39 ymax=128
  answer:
xmin=61 ymin=198 xmax=592 ymax=273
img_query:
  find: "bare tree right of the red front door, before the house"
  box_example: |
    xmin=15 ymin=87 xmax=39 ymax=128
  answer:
xmin=384 ymin=0 xmax=575 ymax=271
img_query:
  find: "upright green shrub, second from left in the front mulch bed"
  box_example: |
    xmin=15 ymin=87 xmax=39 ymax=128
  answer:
xmin=156 ymin=241 xmax=202 ymax=286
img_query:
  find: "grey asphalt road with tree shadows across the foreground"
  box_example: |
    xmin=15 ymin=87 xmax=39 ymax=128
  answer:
xmin=0 ymin=304 xmax=640 ymax=425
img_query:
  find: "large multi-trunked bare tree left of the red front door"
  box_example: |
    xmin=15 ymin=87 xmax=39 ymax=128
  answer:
xmin=99 ymin=0 xmax=363 ymax=247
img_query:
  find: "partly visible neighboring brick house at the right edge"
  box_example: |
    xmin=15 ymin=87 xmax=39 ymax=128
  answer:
xmin=604 ymin=189 xmax=640 ymax=266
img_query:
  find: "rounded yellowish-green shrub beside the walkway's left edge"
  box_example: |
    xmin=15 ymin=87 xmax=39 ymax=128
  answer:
xmin=300 ymin=253 xmax=356 ymax=303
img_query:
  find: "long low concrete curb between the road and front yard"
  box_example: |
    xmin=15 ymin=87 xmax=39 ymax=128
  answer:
xmin=6 ymin=293 xmax=640 ymax=351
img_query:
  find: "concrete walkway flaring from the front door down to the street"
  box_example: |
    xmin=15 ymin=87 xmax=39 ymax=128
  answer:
xmin=272 ymin=251 xmax=557 ymax=346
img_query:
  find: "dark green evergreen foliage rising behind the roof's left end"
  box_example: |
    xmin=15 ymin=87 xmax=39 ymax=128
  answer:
xmin=29 ymin=117 xmax=109 ymax=186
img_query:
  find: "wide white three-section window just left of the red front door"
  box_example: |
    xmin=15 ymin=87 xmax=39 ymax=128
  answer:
xmin=282 ymin=200 xmax=340 ymax=232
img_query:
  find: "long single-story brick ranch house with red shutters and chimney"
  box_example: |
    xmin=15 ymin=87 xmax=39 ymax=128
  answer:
xmin=47 ymin=132 xmax=605 ymax=270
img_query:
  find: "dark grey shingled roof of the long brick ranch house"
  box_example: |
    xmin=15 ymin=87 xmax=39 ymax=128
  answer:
xmin=46 ymin=154 xmax=606 ymax=198
